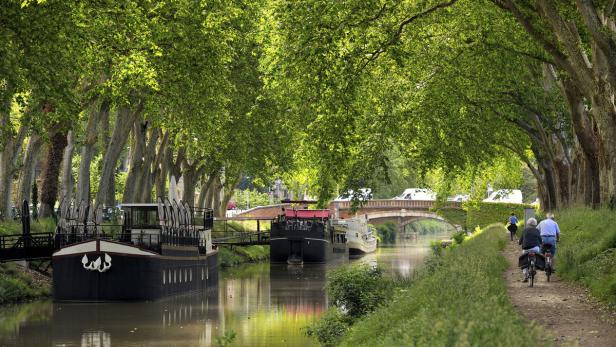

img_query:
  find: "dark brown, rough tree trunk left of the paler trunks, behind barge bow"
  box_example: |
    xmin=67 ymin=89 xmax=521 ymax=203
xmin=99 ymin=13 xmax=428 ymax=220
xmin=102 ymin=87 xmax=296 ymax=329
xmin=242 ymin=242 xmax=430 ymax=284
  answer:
xmin=39 ymin=130 xmax=67 ymax=218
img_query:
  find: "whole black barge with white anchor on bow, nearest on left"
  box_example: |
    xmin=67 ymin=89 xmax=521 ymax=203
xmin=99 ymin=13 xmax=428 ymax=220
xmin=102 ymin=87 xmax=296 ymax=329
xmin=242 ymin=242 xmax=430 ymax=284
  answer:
xmin=52 ymin=200 xmax=218 ymax=301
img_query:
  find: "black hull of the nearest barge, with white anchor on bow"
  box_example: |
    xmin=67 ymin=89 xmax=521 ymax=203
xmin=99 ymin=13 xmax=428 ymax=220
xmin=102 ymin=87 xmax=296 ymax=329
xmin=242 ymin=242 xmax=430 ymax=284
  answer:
xmin=53 ymin=241 xmax=218 ymax=301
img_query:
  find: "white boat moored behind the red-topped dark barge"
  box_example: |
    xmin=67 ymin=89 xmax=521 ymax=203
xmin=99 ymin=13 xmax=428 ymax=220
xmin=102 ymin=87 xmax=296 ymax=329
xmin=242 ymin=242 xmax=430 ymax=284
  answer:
xmin=332 ymin=218 xmax=377 ymax=257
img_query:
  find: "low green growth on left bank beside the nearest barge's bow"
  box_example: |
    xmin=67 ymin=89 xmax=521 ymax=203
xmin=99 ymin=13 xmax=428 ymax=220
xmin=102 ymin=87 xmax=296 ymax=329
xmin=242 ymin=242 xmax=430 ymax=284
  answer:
xmin=0 ymin=263 xmax=51 ymax=304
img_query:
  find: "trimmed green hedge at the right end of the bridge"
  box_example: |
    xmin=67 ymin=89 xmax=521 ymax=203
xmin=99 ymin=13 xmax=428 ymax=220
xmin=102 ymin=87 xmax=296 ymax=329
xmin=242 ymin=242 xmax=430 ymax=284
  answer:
xmin=463 ymin=201 xmax=534 ymax=228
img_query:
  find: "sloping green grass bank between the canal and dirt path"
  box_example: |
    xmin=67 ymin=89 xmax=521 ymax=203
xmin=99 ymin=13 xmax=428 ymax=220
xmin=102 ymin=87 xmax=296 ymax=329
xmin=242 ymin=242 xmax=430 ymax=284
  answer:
xmin=340 ymin=226 xmax=541 ymax=347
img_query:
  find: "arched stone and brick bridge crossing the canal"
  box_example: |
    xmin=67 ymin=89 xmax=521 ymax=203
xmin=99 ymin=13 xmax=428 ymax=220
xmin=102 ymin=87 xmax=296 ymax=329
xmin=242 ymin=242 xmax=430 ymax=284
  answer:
xmin=238 ymin=199 xmax=461 ymax=230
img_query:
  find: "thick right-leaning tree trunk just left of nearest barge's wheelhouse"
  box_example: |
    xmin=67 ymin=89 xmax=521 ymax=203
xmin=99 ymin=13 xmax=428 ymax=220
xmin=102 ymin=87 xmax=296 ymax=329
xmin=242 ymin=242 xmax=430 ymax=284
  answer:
xmin=96 ymin=103 xmax=143 ymax=206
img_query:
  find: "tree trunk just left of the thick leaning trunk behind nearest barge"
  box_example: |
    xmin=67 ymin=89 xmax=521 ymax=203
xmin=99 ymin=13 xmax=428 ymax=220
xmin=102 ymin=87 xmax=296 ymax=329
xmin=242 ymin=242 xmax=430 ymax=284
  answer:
xmin=76 ymin=100 xmax=110 ymax=201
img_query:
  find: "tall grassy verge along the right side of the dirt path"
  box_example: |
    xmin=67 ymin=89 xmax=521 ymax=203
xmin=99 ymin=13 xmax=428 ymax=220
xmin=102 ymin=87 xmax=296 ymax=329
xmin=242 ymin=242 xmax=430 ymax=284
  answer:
xmin=556 ymin=208 xmax=616 ymax=307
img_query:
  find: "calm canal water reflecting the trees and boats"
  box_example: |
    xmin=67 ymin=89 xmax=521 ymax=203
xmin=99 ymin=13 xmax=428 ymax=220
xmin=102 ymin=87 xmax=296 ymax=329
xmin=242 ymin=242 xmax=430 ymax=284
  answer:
xmin=0 ymin=235 xmax=443 ymax=347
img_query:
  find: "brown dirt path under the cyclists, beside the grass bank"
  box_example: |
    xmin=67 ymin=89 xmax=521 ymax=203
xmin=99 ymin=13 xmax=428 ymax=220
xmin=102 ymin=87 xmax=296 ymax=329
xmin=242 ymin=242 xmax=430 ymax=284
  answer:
xmin=503 ymin=242 xmax=616 ymax=346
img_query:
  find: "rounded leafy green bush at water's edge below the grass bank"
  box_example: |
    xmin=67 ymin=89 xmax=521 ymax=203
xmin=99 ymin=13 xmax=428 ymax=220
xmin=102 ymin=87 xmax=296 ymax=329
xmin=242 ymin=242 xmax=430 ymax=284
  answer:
xmin=327 ymin=264 xmax=392 ymax=321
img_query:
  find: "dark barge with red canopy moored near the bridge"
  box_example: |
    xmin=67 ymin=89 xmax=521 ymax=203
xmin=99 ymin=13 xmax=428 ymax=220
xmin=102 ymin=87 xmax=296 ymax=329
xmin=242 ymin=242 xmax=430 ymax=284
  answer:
xmin=270 ymin=205 xmax=348 ymax=265
